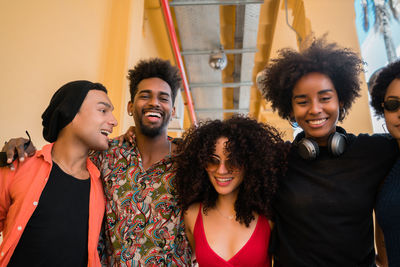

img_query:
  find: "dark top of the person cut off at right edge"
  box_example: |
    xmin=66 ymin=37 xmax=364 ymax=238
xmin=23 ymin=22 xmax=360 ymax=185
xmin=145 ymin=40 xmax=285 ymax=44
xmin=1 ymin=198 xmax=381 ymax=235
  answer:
xmin=375 ymin=158 xmax=400 ymax=266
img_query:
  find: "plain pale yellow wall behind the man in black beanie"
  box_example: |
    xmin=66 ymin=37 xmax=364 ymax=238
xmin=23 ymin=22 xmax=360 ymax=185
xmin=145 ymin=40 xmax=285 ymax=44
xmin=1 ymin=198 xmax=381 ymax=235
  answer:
xmin=0 ymin=0 xmax=110 ymax=147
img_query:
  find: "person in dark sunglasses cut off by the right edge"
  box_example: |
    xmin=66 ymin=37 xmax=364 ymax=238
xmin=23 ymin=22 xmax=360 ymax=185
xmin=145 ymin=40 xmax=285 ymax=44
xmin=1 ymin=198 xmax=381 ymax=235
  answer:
xmin=371 ymin=60 xmax=400 ymax=266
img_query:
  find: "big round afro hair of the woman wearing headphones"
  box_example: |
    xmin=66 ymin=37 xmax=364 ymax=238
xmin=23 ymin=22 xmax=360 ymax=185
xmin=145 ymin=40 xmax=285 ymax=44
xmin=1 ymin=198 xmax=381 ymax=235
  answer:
xmin=259 ymin=37 xmax=364 ymax=121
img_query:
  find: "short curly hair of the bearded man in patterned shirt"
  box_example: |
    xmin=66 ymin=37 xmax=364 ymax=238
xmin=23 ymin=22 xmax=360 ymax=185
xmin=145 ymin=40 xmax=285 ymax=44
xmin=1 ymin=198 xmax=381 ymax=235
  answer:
xmin=127 ymin=58 xmax=182 ymax=104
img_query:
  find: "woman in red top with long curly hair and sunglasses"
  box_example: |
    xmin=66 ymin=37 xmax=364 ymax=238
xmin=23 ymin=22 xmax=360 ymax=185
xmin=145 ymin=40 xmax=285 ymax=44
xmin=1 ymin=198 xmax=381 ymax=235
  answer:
xmin=175 ymin=115 xmax=290 ymax=267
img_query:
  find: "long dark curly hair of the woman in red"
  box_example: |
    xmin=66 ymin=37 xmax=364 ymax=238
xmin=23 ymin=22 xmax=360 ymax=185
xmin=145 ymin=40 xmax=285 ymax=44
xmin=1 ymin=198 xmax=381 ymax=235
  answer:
xmin=175 ymin=115 xmax=290 ymax=226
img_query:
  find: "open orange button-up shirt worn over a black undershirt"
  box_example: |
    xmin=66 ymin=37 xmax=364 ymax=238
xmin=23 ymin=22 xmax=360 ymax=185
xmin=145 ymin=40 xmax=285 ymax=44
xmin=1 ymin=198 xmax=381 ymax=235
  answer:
xmin=0 ymin=144 xmax=105 ymax=267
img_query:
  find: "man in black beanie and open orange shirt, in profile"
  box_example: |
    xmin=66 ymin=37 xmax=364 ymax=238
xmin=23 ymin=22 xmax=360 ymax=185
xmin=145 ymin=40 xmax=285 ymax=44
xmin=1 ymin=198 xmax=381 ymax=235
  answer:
xmin=0 ymin=81 xmax=117 ymax=266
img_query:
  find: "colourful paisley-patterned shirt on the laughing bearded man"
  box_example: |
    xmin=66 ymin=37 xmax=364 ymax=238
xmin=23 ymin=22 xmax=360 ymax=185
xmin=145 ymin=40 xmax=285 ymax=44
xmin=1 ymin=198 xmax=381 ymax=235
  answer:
xmin=92 ymin=140 xmax=191 ymax=266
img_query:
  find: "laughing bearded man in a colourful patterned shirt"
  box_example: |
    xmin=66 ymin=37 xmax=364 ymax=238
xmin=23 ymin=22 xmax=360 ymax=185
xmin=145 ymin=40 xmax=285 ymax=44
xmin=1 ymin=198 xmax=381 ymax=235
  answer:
xmin=3 ymin=59 xmax=191 ymax=266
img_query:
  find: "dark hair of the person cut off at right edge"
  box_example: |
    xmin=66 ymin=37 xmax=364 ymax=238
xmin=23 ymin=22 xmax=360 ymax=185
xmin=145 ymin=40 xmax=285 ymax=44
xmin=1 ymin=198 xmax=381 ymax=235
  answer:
xmin=371 ymin=60 xmax=400 ymax=117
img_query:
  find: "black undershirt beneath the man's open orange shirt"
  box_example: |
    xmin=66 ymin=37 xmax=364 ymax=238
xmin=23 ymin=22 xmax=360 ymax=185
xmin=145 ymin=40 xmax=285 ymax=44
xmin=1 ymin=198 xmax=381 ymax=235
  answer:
xmin=8 ymin=162 xmax=90 ymax=267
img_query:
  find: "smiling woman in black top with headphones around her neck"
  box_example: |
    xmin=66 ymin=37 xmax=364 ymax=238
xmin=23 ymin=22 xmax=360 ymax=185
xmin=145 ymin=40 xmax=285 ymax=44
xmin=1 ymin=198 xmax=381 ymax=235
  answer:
xmin=259 ymin=38 xmax=398 ymax=267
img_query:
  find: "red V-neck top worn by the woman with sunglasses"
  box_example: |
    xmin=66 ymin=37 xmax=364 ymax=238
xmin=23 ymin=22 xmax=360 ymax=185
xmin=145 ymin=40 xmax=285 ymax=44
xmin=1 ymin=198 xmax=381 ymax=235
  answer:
xmin=194 ymin=205 xmax=271 ymax=267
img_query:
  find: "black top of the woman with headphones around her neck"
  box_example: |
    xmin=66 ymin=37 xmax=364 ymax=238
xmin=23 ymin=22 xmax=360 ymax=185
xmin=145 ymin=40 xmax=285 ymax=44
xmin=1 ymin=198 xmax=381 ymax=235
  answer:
xmin=271 ymin=134 xmax=398 ymax=267
